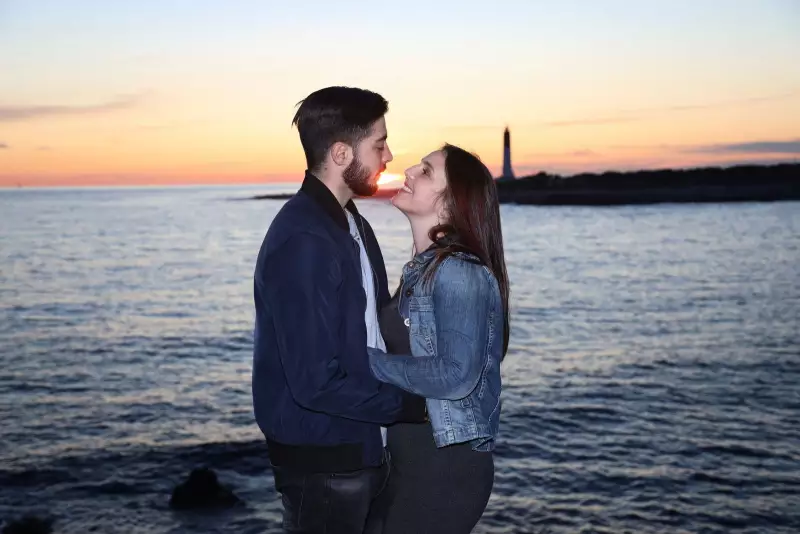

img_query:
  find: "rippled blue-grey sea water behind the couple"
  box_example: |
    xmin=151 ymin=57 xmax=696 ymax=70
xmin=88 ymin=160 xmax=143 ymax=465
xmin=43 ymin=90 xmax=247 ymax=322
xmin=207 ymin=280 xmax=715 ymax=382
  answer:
xmin=0 ymin=188 xmax=800 ymax=534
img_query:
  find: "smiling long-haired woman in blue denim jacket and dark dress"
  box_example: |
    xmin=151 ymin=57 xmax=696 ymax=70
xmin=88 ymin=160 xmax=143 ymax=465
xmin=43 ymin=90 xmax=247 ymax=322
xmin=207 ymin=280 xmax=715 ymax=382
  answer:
xmin=369 ymin=145 xmax=508 ymax=534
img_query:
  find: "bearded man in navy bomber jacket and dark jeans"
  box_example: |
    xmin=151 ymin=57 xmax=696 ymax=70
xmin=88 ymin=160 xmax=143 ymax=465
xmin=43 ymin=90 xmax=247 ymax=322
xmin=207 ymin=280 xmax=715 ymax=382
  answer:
xmin=252 ymin=87 xmax=425 ymax=534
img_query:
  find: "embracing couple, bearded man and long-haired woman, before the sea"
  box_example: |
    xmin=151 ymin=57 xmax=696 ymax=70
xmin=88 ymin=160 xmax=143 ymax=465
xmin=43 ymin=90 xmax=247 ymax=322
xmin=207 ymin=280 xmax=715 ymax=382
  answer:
xmin=252 ymin=87 xmax=508 ymax=534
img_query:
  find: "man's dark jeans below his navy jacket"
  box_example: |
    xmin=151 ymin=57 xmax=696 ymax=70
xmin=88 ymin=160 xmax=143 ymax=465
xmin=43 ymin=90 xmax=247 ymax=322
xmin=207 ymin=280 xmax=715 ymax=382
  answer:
xmin=272 ymin=452 xmax=390 ymax=534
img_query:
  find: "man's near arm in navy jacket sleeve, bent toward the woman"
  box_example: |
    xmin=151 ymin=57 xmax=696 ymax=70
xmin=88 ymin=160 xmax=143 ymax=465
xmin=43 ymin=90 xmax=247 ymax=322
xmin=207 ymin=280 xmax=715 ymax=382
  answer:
xmin=257 ymin=233 xmax=424 ymax=424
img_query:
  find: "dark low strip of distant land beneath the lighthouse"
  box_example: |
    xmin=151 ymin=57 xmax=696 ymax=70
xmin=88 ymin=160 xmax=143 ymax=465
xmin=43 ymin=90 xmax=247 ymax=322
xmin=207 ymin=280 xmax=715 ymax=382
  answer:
xmin=252 ymin=163 xmax=800 ymax=206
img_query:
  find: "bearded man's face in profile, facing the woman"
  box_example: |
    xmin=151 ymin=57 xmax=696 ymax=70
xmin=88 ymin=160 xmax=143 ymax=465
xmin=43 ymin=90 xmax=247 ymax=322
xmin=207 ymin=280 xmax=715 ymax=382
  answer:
xmin=342 ymin=117 xmax=392 ymax=197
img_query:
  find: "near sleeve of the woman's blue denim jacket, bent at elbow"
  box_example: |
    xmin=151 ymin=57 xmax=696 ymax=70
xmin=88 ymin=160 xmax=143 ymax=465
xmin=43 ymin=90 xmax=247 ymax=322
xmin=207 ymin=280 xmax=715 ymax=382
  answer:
xmin=368 ymin=257 xmax=494 ymax=400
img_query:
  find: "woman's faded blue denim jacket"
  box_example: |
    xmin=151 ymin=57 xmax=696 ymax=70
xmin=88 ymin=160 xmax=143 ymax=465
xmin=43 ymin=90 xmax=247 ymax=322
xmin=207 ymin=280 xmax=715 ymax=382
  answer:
xmin=368 ymin=249 xmax=503 ymax=451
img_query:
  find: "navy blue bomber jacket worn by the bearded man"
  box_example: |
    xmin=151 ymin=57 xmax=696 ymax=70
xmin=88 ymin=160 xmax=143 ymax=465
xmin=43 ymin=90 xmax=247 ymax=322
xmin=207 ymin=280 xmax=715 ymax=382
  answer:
xmin=252 ymin=172 xmax=425 ymax=472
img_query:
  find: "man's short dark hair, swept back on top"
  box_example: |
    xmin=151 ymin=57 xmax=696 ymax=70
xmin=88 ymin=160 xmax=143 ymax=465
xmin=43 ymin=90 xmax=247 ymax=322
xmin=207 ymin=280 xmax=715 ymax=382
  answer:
xmin=292 ymin=87 xmax=389 ymax=172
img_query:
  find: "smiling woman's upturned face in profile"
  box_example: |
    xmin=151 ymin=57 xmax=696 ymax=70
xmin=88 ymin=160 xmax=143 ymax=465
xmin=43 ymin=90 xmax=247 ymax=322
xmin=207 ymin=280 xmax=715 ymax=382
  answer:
xmin=392 ymin=150 xmax=447 ymax=221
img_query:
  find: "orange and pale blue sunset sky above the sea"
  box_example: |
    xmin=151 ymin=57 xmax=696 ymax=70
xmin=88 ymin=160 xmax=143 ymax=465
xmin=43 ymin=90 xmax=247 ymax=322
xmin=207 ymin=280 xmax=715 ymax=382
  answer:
xmin=0 ymin=0 xmax=800 ymax=186
